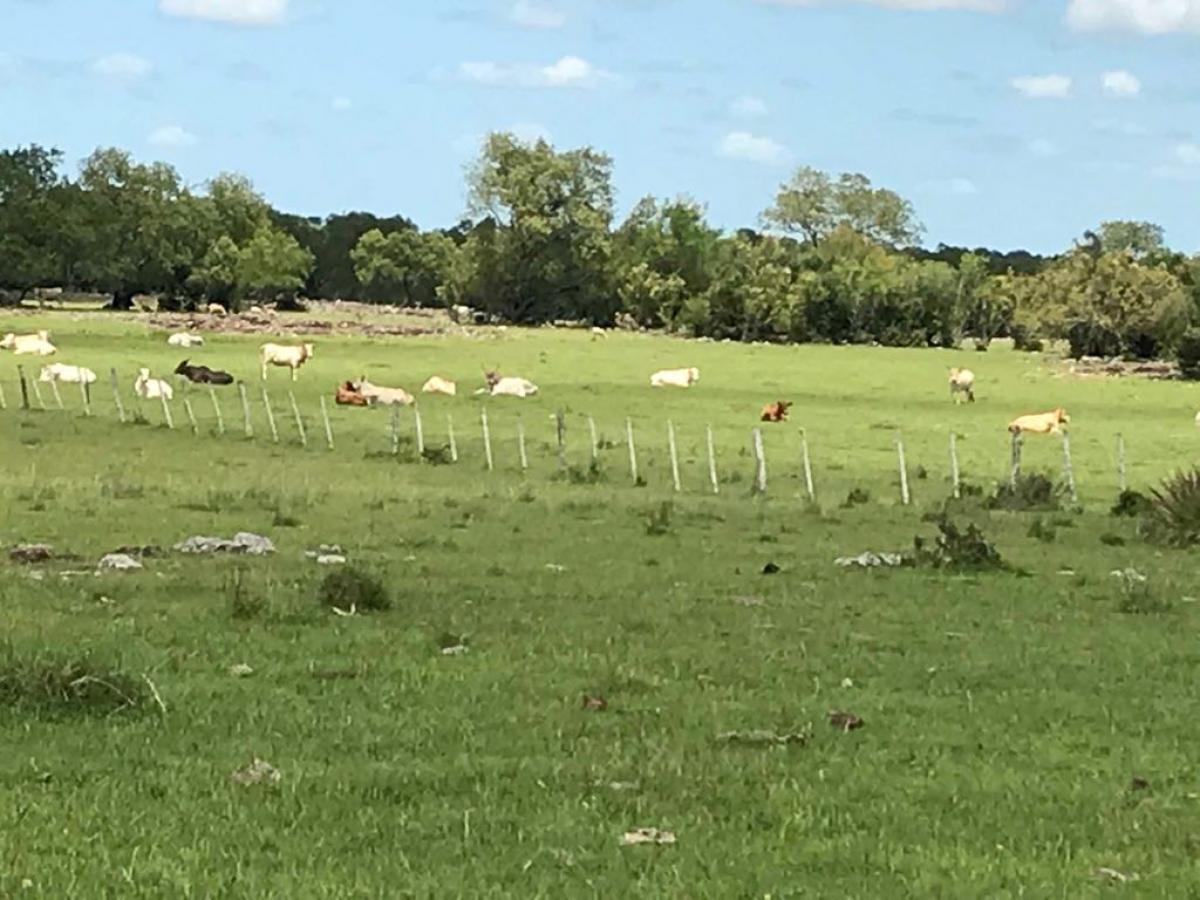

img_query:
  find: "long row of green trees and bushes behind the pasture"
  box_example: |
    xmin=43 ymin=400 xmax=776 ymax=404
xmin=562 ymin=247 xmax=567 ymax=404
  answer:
xmin=0 ymin=133 xmax=1200 ymax=358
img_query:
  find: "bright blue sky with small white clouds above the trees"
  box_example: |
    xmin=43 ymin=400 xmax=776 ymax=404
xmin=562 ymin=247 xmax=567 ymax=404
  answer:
xmin=0 ymin=0 xmax=1200 ymax=252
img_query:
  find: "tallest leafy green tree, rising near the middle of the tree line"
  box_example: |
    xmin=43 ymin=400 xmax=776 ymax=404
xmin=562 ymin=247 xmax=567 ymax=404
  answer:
xmin=455 ymin=133 xmax=616 ymax=323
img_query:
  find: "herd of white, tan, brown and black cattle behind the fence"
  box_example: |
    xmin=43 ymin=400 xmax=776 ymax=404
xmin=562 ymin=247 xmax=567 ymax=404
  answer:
xmin=0 ymin=330 xmax=1084 ymax=434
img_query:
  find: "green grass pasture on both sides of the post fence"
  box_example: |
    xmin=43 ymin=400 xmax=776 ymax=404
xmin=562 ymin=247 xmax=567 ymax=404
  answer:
xmin=0 ymin=313 xmax=1200 ymax=898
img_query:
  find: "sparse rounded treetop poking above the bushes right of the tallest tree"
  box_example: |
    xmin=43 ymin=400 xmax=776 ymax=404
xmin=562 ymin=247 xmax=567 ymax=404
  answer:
xmin=762 ymin=166 xmax=923 ymax=247
